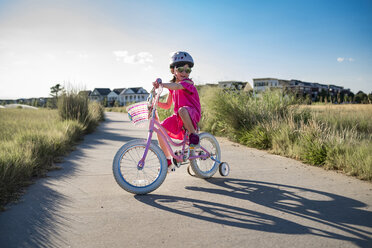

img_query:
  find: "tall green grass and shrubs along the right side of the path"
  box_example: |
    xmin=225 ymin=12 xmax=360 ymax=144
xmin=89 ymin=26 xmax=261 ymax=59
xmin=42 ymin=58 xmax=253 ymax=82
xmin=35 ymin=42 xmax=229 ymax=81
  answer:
xmin=200 ymin=88 xmax=372 ymax=180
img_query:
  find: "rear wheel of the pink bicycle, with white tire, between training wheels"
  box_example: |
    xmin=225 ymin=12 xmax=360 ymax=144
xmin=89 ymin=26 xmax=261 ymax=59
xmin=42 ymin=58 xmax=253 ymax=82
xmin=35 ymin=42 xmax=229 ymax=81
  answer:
xmin=190 ymin=133 xmax=221 ymax=178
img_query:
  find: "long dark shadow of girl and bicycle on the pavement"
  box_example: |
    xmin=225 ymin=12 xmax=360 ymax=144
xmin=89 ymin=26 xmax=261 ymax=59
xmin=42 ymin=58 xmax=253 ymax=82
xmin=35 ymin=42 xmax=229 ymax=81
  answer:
xmin=135 ymin=178 xmax=372 ymax=247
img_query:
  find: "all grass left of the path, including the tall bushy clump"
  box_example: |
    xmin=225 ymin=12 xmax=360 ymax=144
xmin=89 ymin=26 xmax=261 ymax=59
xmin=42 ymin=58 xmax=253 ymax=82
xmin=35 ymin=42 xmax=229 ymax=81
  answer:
xmin=0 ymin=93 xmax=103 ymax=208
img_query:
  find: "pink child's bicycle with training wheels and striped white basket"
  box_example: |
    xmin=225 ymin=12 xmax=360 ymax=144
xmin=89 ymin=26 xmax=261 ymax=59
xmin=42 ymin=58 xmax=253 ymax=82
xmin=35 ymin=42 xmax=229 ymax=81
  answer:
xmin=113 ymin=80 xmax=230 ymax=195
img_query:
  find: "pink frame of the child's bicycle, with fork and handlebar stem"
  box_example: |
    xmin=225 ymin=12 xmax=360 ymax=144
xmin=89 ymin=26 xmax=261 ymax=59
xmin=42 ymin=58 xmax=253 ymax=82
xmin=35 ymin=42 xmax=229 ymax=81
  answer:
xmin=138 ymin=85 xmax=211 ymax=169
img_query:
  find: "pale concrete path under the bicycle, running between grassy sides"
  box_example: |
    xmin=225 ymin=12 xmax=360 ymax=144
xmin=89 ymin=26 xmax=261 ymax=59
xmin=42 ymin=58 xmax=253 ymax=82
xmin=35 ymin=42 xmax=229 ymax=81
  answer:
xmin=0 ymin=113 xmax=372 ymax=248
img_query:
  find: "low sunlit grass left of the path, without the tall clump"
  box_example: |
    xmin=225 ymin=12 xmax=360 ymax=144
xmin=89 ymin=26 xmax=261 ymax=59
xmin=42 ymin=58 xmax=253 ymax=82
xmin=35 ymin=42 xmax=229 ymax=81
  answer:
xmin=0 ymin=109 xmax=84 ymax=206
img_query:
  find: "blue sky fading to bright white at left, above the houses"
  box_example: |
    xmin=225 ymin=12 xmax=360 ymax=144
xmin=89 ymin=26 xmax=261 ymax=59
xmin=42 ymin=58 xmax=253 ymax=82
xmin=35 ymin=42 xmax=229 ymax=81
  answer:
xmin=0 ymin=0 xmax=372 ymax=99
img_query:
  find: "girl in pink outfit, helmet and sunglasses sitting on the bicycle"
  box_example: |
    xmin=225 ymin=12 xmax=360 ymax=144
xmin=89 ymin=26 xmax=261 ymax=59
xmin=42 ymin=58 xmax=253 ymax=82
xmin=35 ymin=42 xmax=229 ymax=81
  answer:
xmin=153 ymin=52 xmax=201 ymax=170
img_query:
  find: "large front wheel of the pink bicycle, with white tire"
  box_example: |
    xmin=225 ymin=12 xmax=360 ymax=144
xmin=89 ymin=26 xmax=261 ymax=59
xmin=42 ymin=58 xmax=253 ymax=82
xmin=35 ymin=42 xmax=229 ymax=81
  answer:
xmin=112 ymin=140 xmax=168 ymax=195
